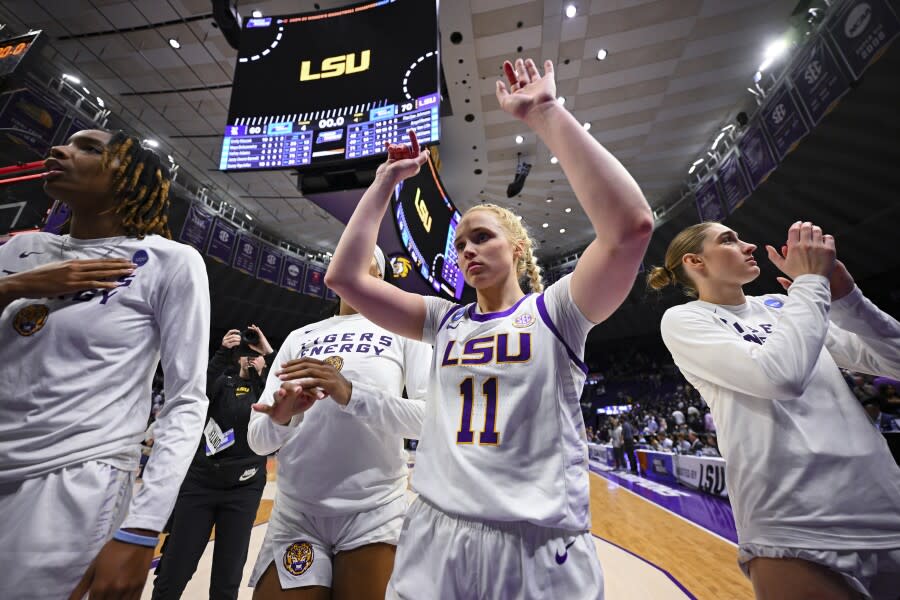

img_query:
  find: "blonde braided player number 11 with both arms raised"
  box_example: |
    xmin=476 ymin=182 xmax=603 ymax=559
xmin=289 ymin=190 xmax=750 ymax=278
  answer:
xmin=326 ymin=59 xmax=653 ymax=598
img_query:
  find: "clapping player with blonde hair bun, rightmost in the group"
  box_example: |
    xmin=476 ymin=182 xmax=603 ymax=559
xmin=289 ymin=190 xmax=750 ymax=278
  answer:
xmin=648 ymin=222 xmax=900 ymax=600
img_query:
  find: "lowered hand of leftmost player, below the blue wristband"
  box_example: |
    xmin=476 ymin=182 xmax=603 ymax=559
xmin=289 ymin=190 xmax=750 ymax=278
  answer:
xmin=69 ymin=540 xmax=154 ymax=600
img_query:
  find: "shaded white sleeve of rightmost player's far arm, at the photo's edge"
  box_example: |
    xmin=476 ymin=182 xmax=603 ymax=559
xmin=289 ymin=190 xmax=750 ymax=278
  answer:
xmin=825 ymin=288 xmax=900 ymax=379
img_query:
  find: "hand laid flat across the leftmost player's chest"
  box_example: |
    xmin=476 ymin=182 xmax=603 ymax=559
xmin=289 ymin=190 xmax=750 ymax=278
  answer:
xmin=3 ymin=258 xmax=137 ymax=298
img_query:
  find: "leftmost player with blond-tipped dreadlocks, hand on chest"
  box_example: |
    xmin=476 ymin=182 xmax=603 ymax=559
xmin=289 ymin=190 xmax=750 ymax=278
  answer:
xmin=0 ymin=130 xmax=210 ymax=600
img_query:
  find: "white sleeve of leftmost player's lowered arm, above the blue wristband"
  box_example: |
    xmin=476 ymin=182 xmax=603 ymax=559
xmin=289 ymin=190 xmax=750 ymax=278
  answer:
xmin=122 ymin=249 xmax=210 ymax=531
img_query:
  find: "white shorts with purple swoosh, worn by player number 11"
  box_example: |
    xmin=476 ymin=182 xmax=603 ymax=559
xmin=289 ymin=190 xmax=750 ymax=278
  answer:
xmin=386 ymin=496 xmax=603 ymax=600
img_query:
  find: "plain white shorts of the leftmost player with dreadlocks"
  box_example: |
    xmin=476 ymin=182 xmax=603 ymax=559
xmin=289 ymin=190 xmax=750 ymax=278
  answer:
xmin=0 ymin=461 xmax=134 ymax=600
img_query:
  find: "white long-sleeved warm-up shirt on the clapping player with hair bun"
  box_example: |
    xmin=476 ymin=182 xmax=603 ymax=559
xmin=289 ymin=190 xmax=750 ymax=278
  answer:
xmin=662 ymin=275 xmax=900 ymax=550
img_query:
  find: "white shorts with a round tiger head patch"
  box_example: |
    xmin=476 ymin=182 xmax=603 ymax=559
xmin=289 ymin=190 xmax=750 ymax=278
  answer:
xmin=249 ymin=496 xmax=406 ymax=590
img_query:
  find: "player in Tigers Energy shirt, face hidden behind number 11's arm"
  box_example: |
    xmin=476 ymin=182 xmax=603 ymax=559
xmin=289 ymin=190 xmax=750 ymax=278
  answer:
xmin=248 ymin=249 xmax=431 ymax=600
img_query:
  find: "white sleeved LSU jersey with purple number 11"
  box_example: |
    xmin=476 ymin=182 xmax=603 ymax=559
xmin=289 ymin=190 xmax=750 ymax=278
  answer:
xmin=413 ymin=276 xmax=594 ymax=531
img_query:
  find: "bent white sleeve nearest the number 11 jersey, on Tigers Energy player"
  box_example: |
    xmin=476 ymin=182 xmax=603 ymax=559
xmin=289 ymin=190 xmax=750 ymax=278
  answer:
xmin=341 ymin=339 xmax=431 ymax=439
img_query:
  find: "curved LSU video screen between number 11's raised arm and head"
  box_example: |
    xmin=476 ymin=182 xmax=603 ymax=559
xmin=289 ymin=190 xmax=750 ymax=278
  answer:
xmin=392 ymin=152 xmax=466 ymax=300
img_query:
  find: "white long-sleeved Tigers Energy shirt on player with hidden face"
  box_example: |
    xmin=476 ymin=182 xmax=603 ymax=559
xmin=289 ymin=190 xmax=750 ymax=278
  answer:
xmin=247 ymin=314 xmax=431 ymax=517
